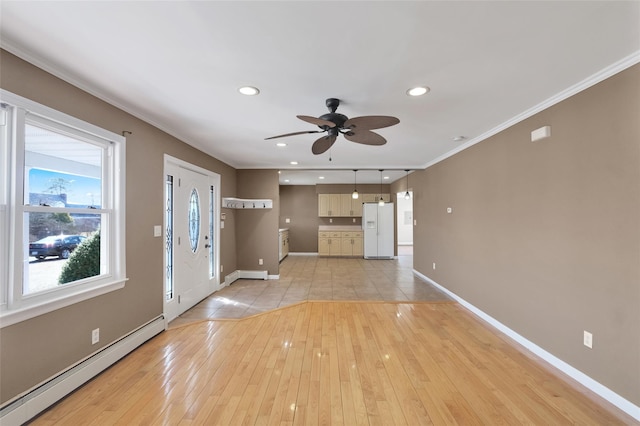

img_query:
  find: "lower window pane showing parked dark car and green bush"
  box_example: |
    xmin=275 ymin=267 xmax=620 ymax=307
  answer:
xmin=22 ymin=212 xmax=104 ymax=295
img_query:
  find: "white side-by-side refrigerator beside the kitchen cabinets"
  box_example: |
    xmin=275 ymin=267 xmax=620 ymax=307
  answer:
xmin=362 ymin=203 xmax=395 ymax=259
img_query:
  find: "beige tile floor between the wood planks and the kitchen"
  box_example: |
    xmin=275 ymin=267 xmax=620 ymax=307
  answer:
xmin=169 ymin=247 xmax=451 ymax=327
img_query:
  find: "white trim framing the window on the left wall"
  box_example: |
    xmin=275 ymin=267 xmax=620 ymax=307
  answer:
xmin=0 ymin=89 xmax=127 ymax=328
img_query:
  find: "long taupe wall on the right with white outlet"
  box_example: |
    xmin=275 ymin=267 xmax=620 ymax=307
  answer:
xmin=411 ymin=66 xmax=640 ymax=405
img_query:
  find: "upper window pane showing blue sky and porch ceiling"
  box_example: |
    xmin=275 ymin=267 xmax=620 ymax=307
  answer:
xmin=24 ymin=125 xmax=104 ymax=208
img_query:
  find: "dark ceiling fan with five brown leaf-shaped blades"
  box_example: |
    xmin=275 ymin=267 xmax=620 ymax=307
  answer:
xmin=265 ymin=98 xmax=400 ymax=155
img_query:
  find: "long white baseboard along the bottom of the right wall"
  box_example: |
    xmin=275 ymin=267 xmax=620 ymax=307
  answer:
xmin=413 ymin=269 xmax=640 ymax=421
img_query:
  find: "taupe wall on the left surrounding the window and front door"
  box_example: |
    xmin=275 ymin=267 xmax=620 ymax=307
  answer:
xmin=0 ymin=51 xmax=240 ymax=402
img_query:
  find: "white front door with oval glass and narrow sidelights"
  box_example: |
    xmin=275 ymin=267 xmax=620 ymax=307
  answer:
xmin=165 ymin=160 xmax=219 ymax=321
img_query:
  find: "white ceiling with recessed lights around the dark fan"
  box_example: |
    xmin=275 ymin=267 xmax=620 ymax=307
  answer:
xmin=0 ymin=0 xmax=640 ymax=184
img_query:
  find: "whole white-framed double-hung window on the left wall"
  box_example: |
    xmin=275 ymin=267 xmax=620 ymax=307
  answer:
xmin=0 ymin=91 xmax=126 ymax=326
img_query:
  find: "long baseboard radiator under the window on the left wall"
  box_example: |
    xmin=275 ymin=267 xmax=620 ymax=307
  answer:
xmin=0 ymin=315 xmax=165 ymax=426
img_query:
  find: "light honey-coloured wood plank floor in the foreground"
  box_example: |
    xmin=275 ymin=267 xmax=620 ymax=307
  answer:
xmin=33 ymin=255 xmax=637 ymax=425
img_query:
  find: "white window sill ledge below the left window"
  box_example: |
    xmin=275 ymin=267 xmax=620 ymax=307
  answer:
xmin=0 ymin=278 xmax=128 ymax=328
